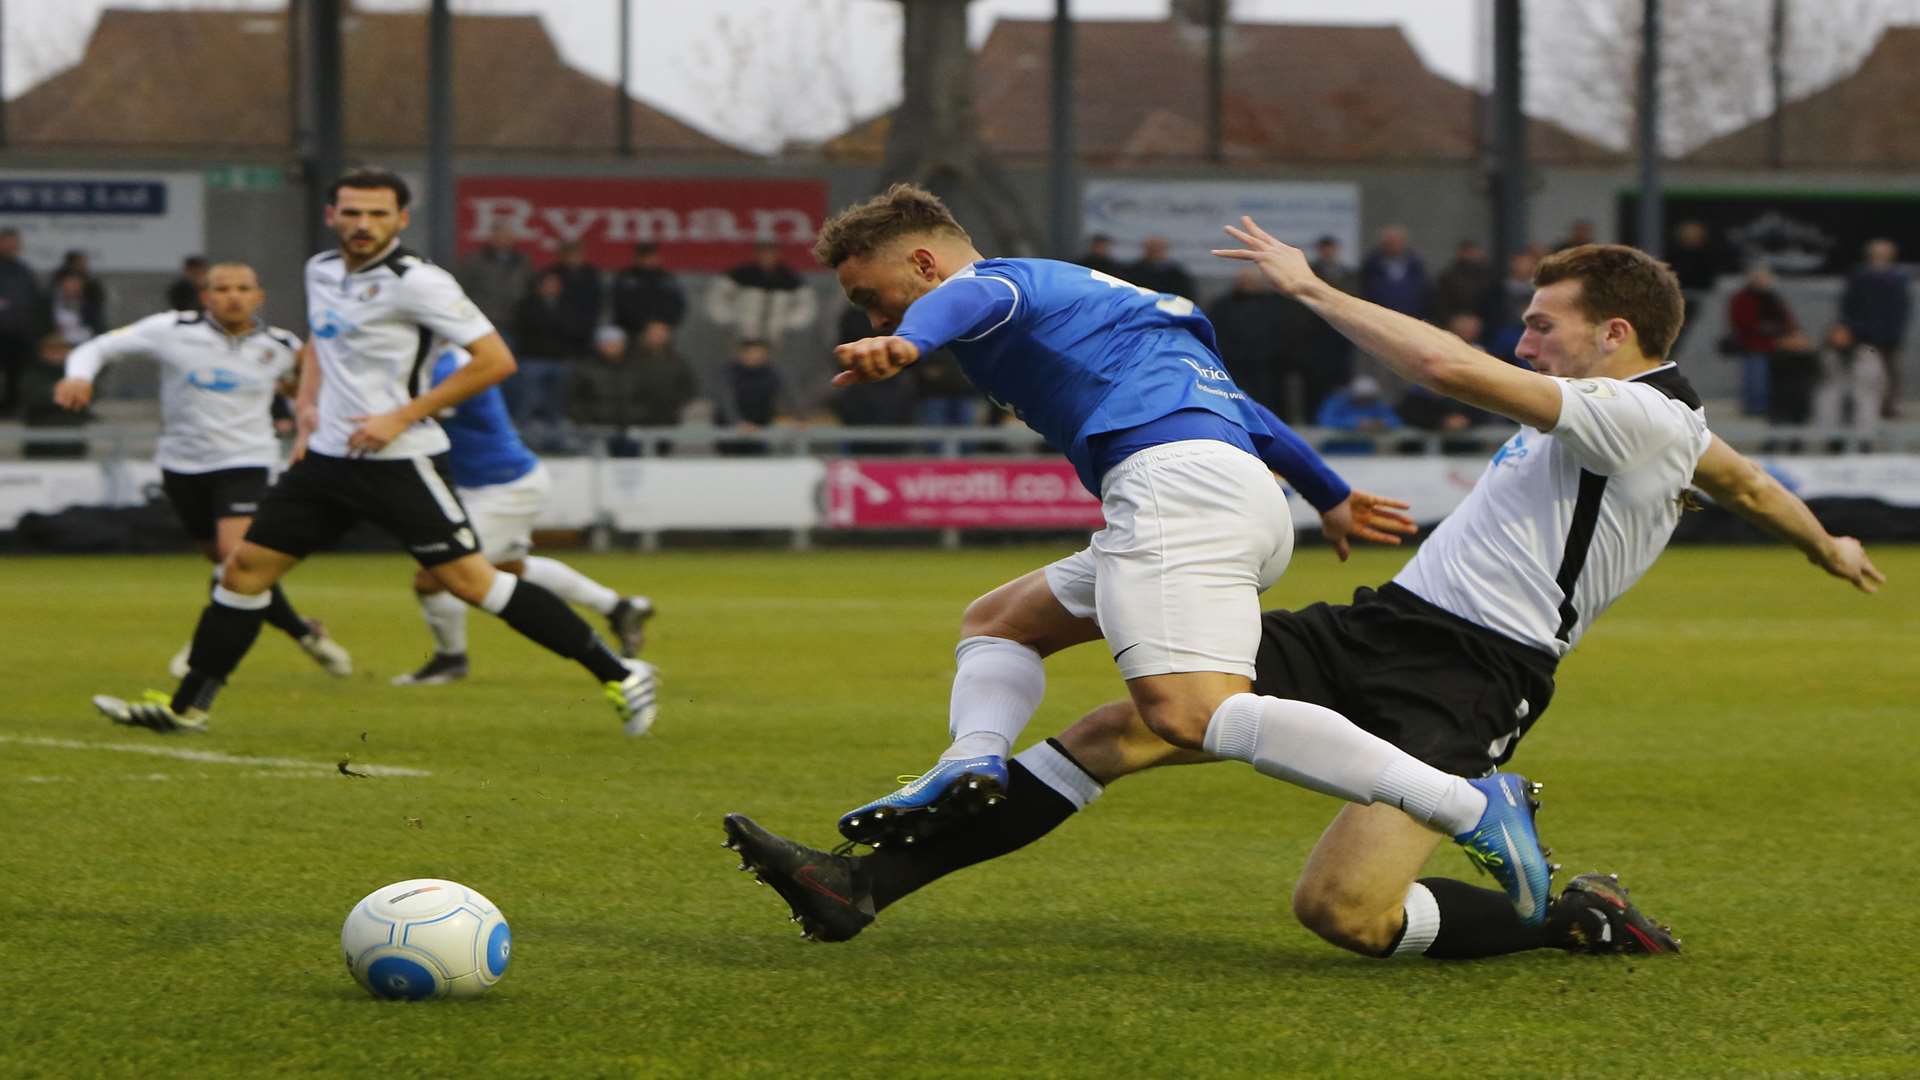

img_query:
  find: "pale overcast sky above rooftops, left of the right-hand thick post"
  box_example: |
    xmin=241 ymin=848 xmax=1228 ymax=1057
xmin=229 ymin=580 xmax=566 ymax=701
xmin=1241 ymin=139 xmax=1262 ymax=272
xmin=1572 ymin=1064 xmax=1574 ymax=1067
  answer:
xmin=4 ymin=0 xmax=1484 ymax=148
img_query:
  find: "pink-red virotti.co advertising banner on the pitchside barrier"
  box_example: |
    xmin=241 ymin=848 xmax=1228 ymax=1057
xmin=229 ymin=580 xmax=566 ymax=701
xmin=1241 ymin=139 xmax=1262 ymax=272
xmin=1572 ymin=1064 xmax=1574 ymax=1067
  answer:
xmin=828 ymin=459 xmax=1104 ymax=530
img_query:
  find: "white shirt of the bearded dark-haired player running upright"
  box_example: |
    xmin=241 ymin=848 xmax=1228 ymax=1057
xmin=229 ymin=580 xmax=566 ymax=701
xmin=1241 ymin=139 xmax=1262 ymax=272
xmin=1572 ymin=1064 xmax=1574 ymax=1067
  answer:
xmin=307 ymin=240 xmax=493 ymax=457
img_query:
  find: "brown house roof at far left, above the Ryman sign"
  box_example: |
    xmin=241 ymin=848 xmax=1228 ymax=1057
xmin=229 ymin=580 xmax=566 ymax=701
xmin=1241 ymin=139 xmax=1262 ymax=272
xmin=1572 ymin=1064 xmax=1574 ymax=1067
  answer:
xmin=8 ymin=10 xmax=743 ymax=158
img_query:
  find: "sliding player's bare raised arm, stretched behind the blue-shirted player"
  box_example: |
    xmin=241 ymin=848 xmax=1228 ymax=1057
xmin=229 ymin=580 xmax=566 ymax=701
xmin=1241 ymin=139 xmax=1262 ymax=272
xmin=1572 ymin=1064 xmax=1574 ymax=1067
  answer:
xmin=1213 ymin=217 xmax=1561 ymax=430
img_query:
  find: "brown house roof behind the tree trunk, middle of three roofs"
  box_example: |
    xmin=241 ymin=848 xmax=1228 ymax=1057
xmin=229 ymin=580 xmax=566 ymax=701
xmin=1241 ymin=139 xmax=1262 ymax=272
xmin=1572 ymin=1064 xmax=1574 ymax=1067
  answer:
xmin=822 ymin=19 xmax=1622 ymax=165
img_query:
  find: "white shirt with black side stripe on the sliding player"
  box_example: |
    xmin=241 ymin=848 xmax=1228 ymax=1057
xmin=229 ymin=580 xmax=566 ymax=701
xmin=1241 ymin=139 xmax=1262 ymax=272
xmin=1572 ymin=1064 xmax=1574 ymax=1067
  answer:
xmin=1394 ymin=363 xmax=1713 ymax=657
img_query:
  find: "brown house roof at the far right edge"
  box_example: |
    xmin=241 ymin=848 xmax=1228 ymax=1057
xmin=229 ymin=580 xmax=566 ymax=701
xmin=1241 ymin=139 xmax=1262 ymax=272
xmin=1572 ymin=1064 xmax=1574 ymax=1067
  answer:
xmin=1682 ymin=27 xmax=1920 ymax=169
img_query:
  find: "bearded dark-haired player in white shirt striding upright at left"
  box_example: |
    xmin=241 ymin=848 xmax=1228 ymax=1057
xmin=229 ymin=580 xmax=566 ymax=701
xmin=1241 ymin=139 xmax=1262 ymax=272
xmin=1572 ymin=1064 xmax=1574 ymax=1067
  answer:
xmin=94 ymin=169 xmax=657 ymax=732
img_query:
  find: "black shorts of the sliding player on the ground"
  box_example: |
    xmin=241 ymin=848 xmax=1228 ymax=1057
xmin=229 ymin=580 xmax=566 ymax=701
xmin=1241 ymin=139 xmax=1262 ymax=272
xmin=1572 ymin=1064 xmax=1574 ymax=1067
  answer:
xmin=1254 ymin=584 xmax=1557 ymax=776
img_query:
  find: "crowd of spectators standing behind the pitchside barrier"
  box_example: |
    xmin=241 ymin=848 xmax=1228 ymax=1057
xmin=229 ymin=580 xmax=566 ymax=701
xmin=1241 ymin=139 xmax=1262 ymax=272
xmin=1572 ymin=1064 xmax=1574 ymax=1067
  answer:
xmin=0 ymin=221 xmax=1910 ymax=455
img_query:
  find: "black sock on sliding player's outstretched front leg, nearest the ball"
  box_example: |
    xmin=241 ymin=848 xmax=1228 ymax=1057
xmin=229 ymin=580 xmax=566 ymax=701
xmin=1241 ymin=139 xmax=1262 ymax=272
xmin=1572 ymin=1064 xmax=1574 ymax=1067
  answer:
xmin=854 ymin=740 xmax=1079 ymax=911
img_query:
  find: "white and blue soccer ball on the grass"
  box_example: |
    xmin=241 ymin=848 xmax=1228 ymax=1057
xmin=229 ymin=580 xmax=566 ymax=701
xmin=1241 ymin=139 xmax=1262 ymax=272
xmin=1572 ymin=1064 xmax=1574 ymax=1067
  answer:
xmin=340 ymin=878 xmax=513 ymax=1001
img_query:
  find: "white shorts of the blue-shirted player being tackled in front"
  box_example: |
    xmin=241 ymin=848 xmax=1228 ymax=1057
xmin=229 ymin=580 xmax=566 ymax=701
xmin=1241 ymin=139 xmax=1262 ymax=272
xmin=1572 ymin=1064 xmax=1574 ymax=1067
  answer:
xmin=1046 ymin=440 xmax=1294 ymax=678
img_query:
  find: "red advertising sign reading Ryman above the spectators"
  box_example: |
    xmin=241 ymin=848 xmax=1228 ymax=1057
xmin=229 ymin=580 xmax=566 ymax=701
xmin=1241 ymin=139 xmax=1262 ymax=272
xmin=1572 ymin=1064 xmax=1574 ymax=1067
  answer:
xmin=455 ymin=177 xmax=828 ymax=271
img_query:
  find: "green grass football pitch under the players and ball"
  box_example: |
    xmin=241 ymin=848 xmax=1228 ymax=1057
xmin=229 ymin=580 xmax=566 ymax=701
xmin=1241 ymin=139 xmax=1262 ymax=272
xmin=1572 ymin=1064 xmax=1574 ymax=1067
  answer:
xmin=0 ymin=546 xmax=1920 ymax=1078
